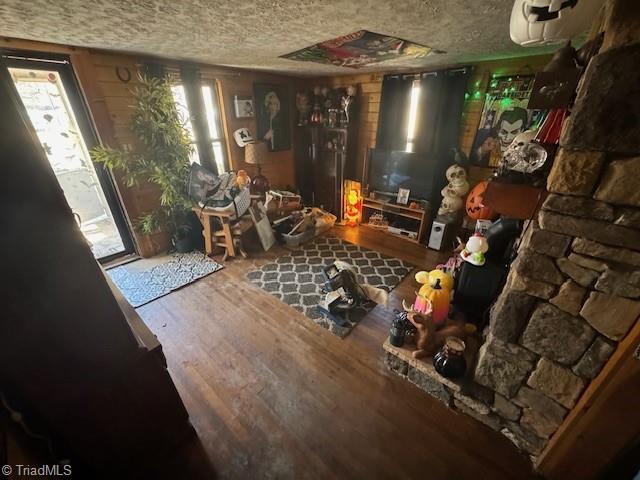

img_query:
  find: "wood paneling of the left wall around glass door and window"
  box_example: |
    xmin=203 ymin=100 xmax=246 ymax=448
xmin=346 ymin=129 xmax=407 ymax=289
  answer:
xmin=0 ymin=37 xmax=298 ymax=257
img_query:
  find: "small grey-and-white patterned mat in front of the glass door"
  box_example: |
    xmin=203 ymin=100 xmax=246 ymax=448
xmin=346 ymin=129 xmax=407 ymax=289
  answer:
xmin=107 ymin=252 xmax=223 ymax=307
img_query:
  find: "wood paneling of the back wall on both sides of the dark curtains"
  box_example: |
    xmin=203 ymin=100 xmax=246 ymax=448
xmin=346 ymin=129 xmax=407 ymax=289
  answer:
xmin=317 ymin=55 xmax=551 ymax=186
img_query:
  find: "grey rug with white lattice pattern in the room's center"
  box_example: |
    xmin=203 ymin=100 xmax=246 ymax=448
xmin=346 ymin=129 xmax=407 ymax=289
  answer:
xmin=247 ymin=236 xmax=414 ymax=337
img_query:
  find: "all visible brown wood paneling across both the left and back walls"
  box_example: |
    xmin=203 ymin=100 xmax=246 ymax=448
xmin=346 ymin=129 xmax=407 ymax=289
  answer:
xmin=0 ymin=37 xmax=550 ymax=256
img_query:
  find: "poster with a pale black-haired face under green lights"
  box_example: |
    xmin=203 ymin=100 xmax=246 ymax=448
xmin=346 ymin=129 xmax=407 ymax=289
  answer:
xmin=470 ymin=75 xmax=545 ymax=167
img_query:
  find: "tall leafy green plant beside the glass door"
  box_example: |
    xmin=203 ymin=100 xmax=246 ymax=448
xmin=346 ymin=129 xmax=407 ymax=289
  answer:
xmin=90 ymin=77 xmax=193 ymax=252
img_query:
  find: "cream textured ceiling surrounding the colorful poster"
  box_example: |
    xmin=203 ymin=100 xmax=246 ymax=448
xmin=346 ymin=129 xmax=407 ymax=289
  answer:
xmin=0 ymin=0 xmax=549 ymax=75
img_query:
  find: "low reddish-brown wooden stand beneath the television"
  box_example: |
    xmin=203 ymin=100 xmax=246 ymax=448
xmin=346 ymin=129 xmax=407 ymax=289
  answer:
xmin=362 ymin=198 xmax=429 ymax=244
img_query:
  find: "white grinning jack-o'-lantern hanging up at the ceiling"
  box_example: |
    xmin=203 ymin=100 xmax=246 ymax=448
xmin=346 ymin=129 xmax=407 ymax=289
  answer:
xmin=510 ymin=0 xmax=603 ymax=46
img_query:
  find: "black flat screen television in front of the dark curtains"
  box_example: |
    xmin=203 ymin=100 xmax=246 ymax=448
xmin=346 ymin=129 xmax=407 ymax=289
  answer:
xmin=369 ymin=148 xmax=446 ymax=200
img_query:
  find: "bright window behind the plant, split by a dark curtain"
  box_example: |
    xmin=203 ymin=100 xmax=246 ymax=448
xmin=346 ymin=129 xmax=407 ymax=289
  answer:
xmin=171 ymin=77 xmax=228 ymax=173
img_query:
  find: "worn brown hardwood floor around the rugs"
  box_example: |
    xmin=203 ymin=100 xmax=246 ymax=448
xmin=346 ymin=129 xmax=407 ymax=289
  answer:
xmin=138 ymin=227 xmax=531 ymax=479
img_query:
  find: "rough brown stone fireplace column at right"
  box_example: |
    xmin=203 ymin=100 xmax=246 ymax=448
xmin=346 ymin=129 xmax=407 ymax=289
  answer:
xmin=475 ymin=0 xmax=640 ymax=464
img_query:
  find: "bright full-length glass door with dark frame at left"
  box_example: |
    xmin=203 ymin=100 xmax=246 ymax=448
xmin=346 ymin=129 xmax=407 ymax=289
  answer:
xmin=5 ymin=57 xmax=133 ymax=262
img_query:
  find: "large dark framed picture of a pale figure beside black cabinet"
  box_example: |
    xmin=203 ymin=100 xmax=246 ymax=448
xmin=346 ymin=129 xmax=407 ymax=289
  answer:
xmin=253 ymin=83 xmax=291 ymax=152
